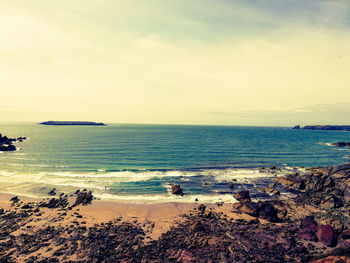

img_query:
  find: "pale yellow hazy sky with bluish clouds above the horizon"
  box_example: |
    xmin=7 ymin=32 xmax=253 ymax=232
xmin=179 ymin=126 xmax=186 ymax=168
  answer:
xmin=0 ymin=0 xmax=350 ymax=126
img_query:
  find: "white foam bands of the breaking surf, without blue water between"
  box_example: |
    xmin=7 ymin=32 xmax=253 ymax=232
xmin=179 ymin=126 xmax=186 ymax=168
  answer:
xmin=0 ymin=167 xmax=300 ymax=203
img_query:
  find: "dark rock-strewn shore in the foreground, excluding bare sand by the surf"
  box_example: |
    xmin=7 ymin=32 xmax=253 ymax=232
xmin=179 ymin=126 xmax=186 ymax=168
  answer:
xmin=0 ymin=164 xmax=350 ymax=263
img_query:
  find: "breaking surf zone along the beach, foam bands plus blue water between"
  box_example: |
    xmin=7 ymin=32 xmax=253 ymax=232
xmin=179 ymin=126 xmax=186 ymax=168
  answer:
xmin=0 ymin=167 xmax=295 ymax=203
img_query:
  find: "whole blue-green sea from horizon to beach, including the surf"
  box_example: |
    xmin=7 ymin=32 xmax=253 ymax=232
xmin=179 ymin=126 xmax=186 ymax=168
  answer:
xmin=0 ymin=123 xmax=350 ymax=204
